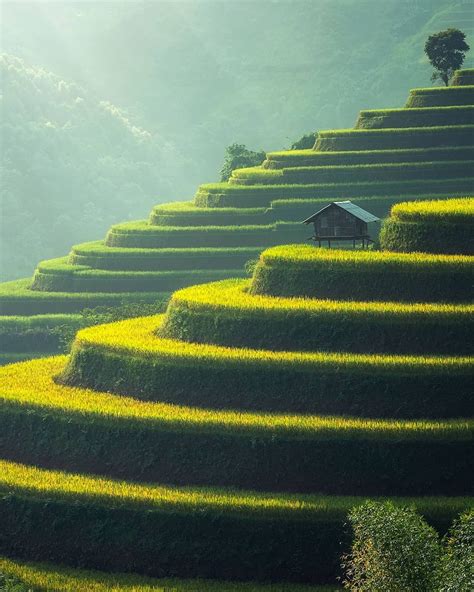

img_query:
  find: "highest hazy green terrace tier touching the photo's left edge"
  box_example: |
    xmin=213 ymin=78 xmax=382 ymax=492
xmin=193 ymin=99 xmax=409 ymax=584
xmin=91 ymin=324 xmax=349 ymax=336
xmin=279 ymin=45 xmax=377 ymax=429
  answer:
xmin=0 ymin=279 xmax=170 ymax=315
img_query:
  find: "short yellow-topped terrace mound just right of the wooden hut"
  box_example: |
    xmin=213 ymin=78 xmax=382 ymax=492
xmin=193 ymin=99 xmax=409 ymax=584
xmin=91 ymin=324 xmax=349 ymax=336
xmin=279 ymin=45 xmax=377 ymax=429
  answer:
xmin=380 ymin=198 xmax=474 ymax=255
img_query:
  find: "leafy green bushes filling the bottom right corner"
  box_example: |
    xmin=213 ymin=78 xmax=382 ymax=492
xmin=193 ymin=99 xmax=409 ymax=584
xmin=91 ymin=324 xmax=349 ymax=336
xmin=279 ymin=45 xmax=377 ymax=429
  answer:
xmin=343 ymin=501 xmax=474 ymax=592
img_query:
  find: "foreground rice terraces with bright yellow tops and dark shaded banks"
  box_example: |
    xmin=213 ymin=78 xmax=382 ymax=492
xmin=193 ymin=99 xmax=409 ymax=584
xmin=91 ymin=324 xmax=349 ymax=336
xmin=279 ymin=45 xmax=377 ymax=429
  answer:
xmin=0 ymin=199 xmax=474 ymax=592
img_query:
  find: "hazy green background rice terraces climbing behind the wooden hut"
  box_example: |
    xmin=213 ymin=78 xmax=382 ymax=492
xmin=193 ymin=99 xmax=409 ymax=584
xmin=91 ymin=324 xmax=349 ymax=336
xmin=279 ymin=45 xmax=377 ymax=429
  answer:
xmin=0 ymin=70 xmax=474 ymax=363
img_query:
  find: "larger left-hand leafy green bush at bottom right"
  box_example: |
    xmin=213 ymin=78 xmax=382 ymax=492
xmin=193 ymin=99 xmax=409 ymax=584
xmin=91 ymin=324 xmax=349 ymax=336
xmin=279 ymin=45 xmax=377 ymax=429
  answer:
xmin=344 ymin=501 xmax=441 ymax=592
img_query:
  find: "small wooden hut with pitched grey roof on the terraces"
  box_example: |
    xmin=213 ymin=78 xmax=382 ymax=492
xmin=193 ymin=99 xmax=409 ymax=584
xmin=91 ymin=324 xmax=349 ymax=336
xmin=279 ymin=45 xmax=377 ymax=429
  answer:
xmin=303 ymin=201 xmax=379 ymax=247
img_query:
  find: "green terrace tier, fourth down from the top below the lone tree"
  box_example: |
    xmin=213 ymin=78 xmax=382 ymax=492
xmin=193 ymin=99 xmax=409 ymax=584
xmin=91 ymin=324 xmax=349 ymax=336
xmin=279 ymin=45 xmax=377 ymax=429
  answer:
xmin=315 ymin=125 xmax=474 ymax=151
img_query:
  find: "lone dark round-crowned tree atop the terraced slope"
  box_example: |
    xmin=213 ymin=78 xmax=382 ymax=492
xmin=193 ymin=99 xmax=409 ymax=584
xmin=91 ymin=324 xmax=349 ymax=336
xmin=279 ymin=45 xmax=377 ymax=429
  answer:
xmin=425 ymin=29 xmax=470 ymax=86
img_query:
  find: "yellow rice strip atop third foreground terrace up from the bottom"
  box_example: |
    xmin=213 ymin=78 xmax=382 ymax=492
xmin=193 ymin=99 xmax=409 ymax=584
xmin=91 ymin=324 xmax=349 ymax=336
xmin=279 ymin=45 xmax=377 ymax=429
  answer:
xmin=0 ymin=357 xmax=468 ymax=440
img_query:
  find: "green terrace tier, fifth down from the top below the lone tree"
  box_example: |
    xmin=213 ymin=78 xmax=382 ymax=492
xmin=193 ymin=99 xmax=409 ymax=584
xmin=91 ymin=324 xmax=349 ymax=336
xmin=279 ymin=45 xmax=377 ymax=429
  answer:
xmin=263 ymin=146 xmax=474 ymax=169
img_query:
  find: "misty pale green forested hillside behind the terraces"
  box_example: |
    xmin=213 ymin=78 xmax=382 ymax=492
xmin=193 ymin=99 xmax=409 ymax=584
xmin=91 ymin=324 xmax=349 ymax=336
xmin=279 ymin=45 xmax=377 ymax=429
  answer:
xmin=0 ymin=0 xmax=473 ymax=279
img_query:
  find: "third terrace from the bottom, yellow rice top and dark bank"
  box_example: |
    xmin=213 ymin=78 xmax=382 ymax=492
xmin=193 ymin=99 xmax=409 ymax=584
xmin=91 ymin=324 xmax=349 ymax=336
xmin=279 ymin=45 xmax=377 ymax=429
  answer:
xmin=0 ymin=358 xmax=474 ymax=495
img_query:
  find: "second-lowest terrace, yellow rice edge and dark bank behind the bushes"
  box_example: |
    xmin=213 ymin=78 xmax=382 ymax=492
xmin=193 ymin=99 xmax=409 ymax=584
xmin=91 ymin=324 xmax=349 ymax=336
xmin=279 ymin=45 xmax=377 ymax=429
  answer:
xmin=0 ymin=461 xmax=471 ymax=583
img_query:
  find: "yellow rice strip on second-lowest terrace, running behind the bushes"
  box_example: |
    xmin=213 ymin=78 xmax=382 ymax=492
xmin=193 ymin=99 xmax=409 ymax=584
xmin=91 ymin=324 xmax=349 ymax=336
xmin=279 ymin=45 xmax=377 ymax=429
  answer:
xmin=0 ymin=460 xmax=470 ymax=520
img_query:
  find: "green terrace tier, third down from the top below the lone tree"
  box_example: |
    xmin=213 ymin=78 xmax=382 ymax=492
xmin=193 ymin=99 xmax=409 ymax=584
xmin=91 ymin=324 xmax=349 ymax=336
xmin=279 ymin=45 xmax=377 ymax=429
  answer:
xmin=355 ymin=105 xmax=474 ymax=129
